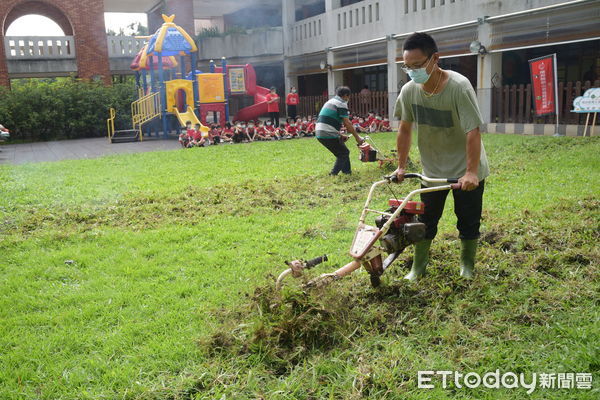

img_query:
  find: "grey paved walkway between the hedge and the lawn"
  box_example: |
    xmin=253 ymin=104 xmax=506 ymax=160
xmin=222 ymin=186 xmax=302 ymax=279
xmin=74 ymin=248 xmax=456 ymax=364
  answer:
xmin=0 ymin=138 xmax=181 ymax=164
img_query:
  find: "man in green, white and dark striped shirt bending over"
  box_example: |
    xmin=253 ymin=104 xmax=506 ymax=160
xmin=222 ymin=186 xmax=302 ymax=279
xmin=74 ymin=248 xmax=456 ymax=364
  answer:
xmin=315 ymin=86 xmax=363 ymax=175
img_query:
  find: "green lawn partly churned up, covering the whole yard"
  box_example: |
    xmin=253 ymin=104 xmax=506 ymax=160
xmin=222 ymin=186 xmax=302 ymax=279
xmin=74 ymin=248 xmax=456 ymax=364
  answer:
xmin=0 ymin=133 xmax=600 ymax=400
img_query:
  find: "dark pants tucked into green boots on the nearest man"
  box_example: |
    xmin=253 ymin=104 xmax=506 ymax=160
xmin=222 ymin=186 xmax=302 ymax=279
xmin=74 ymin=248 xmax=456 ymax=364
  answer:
xmin=419 ymin=180 xmax=485 ymax=240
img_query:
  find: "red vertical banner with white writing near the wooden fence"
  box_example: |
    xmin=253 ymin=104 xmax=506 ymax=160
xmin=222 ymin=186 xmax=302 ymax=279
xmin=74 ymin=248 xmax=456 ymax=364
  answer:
xmin=529 ymin=54 xmax=557 ymax=116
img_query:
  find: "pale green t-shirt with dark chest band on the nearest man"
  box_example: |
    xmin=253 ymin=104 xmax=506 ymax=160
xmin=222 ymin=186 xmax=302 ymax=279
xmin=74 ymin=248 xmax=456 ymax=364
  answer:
xmin=394 ymin=71 xmax=490 ymax=186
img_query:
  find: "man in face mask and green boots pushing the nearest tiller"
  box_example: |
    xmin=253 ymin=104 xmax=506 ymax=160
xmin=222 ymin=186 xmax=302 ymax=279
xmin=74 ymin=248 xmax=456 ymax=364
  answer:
xmin=395 ymin=32 xmax=489 ymax=280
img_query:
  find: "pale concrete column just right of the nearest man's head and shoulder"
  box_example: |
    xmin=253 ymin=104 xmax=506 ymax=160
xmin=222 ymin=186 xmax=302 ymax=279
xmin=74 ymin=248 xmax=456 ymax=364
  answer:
xmin=477 ymin=22 xmax=502 ymax=123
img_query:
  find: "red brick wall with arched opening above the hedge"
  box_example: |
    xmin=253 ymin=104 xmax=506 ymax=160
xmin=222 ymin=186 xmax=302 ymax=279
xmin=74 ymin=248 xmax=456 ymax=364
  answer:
xmin=0 ymin=0 xmax=111 ymax=86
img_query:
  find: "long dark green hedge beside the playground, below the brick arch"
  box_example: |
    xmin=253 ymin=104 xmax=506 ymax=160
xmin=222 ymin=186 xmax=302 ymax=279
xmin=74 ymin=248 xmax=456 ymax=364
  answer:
xmin=0 ymin=79 xmax=137 ymax=141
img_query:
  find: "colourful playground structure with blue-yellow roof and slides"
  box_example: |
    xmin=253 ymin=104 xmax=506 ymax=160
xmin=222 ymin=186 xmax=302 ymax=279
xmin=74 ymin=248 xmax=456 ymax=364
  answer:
xmin=107 ymin=15 xmax=269 ymax=143
